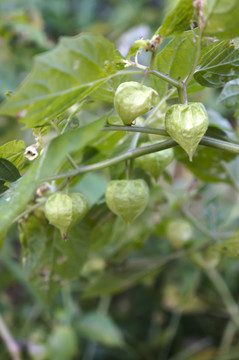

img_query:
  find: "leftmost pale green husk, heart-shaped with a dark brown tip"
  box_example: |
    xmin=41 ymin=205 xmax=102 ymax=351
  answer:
xmin=45 ymin=192 xmax=88 ymax=239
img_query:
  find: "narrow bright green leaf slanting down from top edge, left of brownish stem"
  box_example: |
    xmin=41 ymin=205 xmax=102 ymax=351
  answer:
xmin=155 ymin=0 xmax=194 ymax=38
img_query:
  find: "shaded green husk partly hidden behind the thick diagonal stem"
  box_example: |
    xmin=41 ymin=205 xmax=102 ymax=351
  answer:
xmin=136 ymin=142 xmax=174 ymax=179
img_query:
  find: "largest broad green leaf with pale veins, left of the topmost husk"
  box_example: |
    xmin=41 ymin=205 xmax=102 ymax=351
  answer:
xmin=0 ymin=34 xmax=118 ymax=127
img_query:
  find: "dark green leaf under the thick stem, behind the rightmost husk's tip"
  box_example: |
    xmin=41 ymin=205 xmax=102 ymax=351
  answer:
xmin=174 ymin=145 xmax=236 ymax=184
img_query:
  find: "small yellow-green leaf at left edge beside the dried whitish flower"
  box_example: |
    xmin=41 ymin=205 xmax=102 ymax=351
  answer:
xmin=0 ymin=140 xmax=25 ymax=168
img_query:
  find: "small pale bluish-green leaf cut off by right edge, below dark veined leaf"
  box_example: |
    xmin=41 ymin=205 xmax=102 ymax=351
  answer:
xmin=218 ymin=79 xmax=239 ymax=110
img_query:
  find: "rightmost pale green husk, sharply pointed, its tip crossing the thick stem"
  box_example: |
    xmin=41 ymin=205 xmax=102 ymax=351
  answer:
xmin=165 ymin=103 xmax=208 ymax=161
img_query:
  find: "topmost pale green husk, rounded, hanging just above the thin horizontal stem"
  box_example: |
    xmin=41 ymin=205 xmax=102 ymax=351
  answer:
xmin=114 ymin=81 xmax=158 ymax=125
